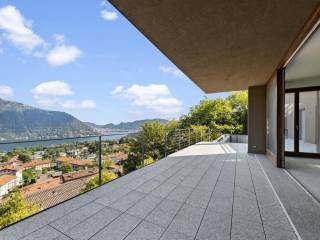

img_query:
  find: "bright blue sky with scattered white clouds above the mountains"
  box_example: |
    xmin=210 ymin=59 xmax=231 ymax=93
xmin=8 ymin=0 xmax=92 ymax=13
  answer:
xmin=0 ymin=0 xmax=228 ymax=124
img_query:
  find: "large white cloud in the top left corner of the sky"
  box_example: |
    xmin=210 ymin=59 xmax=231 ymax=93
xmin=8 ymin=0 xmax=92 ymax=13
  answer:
xmin=0 ymin=5 xmax=45 ymax=52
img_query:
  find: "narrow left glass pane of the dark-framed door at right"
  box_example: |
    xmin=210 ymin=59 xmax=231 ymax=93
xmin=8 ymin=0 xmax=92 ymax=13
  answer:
xmin=284 ymin=93 xmax=294 ymax=152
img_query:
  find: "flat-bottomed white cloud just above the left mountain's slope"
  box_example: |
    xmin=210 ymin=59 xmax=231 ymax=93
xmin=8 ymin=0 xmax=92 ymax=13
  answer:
xmin=31 ymin=81 xmax=74 ymax=96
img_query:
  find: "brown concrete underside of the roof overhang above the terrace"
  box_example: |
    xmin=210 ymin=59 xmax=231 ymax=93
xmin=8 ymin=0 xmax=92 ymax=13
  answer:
xmin=110 ymin=0 xmax=319 ymax=93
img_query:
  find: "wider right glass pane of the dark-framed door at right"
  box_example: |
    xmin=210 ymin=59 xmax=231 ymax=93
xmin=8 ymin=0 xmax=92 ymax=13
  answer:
xmin=298 ymin=91 xmax=320 ymax=153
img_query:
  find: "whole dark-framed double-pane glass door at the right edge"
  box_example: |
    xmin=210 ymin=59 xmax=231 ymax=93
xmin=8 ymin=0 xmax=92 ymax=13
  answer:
xmin=284 ymin=87 xmax=320 ymax=157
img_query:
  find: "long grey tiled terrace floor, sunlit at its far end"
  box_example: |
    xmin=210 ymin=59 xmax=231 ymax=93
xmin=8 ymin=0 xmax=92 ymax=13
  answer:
xmin=0 ymin=143 xmax=304 ymax=240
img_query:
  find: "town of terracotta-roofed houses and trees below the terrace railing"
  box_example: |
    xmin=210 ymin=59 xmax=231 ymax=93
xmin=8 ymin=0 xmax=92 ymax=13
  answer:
xmin=0 ymin=140 xmax=129 ymax=209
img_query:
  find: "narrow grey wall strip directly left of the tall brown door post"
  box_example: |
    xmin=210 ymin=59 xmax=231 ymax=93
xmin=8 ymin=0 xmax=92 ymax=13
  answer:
xmin=266 ymin=78 xmax=277 ymax=157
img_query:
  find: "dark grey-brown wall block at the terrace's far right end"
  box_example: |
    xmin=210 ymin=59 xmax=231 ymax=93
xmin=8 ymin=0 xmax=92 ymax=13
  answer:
xmin=248 ymin=86 xmax=266 ymax=154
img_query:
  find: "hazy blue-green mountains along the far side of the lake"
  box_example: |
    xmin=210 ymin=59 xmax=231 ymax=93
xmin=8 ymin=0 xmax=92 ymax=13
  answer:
xmin=0 ymin=98 xmax=167 ymax=141
